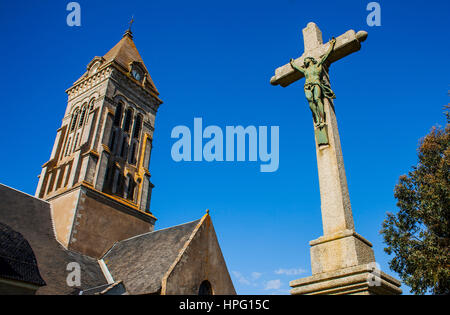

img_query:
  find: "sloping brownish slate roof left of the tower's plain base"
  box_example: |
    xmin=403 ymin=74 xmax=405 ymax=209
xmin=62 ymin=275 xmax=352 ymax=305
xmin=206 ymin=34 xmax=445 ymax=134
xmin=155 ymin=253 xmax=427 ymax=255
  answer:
xmin=0 ymin=184 xmax=107 ymax=294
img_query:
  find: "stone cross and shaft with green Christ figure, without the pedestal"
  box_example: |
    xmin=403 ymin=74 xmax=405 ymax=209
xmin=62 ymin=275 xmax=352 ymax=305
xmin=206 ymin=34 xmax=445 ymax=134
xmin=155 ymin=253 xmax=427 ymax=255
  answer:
xmin=270 ymin=22 xmax=367 ymax=239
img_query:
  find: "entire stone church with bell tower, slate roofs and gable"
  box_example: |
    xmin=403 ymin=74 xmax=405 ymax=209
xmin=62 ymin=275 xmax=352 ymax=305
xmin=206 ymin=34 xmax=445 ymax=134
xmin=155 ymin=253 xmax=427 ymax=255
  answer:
xmin=0 ymin=30 xmax=235 ymax=295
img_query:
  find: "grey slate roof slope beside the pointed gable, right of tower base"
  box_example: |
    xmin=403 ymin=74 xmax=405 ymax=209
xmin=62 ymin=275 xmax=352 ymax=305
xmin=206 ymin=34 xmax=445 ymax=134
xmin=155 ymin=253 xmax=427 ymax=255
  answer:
xmin=103 ymin=220 xmax=201 ymax=294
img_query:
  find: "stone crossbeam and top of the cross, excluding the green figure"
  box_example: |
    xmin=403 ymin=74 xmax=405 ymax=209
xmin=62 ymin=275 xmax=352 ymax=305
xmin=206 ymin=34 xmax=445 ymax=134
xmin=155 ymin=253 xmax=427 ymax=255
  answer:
xmin=270 ymin=22 xmax=367 ymax=87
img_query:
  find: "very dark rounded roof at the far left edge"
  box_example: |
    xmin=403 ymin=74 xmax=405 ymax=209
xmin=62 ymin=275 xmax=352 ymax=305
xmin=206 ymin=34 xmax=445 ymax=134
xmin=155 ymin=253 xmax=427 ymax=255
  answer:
xmin=0 ymin=223 xmax=45 ymax=286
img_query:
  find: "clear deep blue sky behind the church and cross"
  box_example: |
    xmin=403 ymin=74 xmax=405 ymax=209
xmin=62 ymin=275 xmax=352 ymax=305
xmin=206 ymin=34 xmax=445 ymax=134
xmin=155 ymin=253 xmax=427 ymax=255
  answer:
xmin=0 ymin=0 xmax=450 ymax=294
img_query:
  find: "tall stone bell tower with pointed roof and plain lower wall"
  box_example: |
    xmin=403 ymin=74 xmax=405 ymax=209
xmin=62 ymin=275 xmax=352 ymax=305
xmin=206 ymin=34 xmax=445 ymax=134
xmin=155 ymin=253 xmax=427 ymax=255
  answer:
xmin=36 ymin=30 xmax=162 ymax=257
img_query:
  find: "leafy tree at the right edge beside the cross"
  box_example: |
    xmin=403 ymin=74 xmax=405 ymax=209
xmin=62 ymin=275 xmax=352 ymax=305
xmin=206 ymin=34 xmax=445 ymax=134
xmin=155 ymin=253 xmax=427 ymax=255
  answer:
xmin=381 ymin=106 xmax=450 ymax=294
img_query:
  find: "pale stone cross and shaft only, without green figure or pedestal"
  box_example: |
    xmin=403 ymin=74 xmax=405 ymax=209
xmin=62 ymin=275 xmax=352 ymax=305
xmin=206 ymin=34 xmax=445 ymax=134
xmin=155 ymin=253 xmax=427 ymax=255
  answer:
xmin=270 ymin=22 xmax=367 ymax=236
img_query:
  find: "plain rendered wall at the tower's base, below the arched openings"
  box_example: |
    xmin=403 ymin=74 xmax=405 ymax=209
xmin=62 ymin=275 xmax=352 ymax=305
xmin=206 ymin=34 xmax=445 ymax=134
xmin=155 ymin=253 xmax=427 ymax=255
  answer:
xmin=49 ymin=185 xmax=156 ymax=258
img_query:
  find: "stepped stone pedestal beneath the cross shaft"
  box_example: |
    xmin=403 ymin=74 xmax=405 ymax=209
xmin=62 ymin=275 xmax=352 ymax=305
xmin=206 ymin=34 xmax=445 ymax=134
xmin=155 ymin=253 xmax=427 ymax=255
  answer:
xmin=290 ymin=230 xmax=402 ymax=295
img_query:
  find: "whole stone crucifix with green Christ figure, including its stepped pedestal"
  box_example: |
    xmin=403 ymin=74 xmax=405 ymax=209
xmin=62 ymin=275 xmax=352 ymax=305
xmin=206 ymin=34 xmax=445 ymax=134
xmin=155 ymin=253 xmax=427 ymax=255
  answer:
xmin=270 ymin=23 xmax=401 ymax=294
